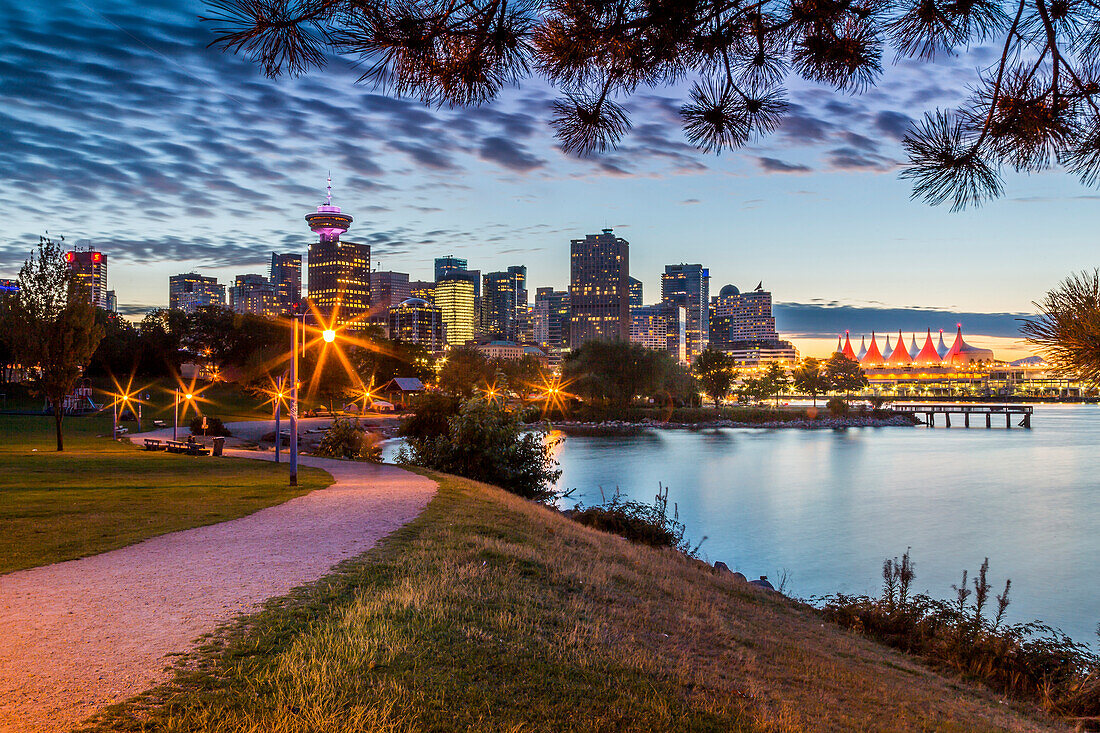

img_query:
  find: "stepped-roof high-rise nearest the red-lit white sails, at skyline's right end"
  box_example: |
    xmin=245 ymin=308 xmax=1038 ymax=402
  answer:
xmin=711 ymin=279 xmax=798 ymax=363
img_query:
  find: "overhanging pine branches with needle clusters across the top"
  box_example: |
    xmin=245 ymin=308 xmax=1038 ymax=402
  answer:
xmin=210 ymin=0 xmax=1100 ymax=209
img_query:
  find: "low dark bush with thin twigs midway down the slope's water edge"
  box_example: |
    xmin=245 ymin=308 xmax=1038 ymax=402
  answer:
xmin=570 ymin=484 xmax=706 ymax=557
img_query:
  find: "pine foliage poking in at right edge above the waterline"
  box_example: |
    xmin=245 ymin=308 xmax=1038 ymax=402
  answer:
xmin=1020 ymin=270 xmax=1100 ymax=384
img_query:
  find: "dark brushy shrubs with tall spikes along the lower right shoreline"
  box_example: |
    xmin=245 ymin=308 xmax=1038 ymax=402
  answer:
xmin=821 ymin=553 xmax=1100 ymax=718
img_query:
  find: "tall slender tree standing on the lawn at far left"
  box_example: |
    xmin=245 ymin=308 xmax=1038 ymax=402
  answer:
xmin=8 ymin=237 xmax=103 ymax=450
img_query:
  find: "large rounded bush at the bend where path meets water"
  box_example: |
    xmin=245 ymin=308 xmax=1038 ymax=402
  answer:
xmin=397 ymin=400 xmax=561 ymax=502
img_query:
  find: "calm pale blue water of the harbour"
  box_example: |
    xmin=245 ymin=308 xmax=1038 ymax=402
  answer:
xmin=389 ymin=405 xmax=1100 ymax=647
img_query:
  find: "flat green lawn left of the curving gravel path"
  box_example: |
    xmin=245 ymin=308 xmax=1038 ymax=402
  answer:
xmin=0 ymin=415 xmax=332 ymax=573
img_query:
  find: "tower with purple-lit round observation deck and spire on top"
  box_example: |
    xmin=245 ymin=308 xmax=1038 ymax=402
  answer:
xmin=306 ymin=178 xmax=371 ymax=325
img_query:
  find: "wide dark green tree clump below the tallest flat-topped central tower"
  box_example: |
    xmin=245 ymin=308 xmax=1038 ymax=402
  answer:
xmin=561 ymin=341 xmax=677 ymax=407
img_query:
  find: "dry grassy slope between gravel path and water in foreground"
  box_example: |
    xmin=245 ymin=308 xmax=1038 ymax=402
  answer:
xmin=81 ymin=468 xmax=1060 ymax=733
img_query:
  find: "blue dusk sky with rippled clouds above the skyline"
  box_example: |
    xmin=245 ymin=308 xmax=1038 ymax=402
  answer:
xmin=0 ymin=0 xmax=1100 ymax=357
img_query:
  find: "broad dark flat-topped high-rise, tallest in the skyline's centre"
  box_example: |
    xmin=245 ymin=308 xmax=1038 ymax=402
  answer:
xmin=569 ymin=229 xmax=630 ymax=349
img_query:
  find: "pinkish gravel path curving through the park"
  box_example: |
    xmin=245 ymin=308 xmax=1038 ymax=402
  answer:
xmin=0 ymin=429 xmax=436 ymax=733
